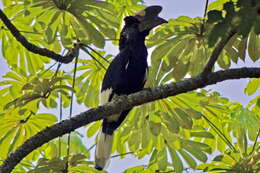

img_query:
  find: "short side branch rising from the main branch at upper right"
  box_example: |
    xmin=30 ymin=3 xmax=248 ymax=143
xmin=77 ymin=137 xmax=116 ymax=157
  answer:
xmin=201 ymin=28 xmax=236 ymax=76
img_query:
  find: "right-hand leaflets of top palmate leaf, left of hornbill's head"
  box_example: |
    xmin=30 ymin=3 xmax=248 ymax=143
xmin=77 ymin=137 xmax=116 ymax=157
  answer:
xmin=68 ymin=0 xmax=117 ymax=48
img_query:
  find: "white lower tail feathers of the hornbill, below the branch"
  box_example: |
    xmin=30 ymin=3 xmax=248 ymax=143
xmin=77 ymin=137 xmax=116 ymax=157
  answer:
xmin=95 ymin=131 xmax=113 ymax=170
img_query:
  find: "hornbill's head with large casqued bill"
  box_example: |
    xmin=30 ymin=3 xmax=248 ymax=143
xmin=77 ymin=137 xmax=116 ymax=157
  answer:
xmin=121 ymin=6 xmax=167 ymax=40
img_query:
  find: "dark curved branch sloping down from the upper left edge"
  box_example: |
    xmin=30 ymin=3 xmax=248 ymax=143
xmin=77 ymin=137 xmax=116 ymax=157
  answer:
xmin=0 ymin=9 xmax=75 ymax=63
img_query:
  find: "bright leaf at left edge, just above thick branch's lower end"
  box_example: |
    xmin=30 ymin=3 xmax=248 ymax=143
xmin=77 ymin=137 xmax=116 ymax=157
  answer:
xmin=0 ymin=111 xmax=57 ymax=158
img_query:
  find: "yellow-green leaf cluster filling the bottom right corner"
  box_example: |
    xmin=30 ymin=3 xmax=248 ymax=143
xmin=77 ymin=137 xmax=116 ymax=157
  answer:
xmin=197 ymin=107 xmax=260 ymax=173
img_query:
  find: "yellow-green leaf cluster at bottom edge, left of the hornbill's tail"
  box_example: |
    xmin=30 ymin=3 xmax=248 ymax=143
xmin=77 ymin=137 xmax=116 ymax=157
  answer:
xmin=28 ymin=134 xmax=94 ymax=173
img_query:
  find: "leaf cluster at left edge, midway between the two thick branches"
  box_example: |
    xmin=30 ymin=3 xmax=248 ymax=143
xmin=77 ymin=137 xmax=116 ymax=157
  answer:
xmin=0 ymin=69 xmax=74 ymax=112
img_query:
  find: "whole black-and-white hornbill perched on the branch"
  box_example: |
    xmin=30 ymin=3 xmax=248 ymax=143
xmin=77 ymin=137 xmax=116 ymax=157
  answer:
xmin=95 ymin=6 xmax=167 ymax=170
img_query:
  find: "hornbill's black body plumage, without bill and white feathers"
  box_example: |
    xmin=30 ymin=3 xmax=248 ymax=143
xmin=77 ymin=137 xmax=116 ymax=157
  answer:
xmin=101 ymin=16 xmax=148 ymax=135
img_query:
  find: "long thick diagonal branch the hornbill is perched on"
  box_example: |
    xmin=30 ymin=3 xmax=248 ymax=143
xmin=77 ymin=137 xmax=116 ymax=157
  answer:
xmin=0 ymin=68 xmax=260 ymax=173
